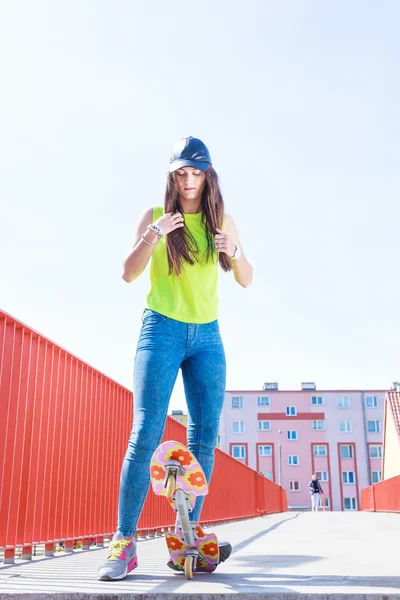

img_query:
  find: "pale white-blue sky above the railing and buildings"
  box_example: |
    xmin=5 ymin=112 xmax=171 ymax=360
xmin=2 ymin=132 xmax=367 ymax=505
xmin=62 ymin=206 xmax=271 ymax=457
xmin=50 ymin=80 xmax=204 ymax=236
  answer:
xmin=0 ymin=0 xmax=400 ymax=408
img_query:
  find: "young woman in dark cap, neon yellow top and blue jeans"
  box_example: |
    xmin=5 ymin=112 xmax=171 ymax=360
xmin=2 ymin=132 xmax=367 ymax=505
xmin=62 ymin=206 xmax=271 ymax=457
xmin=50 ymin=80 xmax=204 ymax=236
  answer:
xmin=99 ymin=137 xmax=253 ymax=580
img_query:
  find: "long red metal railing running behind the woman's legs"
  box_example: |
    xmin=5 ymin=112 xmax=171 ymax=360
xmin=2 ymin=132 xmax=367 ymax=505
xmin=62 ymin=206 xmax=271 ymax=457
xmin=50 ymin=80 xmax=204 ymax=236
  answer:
xmin=0 ymin=311 xmax=287 ymax=559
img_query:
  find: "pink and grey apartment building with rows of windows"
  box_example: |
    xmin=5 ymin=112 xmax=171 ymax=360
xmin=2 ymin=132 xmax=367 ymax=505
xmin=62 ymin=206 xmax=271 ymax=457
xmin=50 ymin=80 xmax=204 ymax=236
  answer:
xmin=220 ymin=383 xmax=385 ymax=510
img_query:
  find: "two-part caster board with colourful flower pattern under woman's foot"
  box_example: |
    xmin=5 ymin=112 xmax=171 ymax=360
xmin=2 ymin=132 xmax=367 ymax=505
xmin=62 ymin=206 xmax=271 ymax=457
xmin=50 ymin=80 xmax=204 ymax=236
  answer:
xmin=150 ymin=441 xmax=219 ymax=579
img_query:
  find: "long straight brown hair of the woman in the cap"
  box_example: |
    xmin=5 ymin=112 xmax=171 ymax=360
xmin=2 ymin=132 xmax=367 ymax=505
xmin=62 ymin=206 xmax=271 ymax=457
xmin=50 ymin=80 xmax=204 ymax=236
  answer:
xmin=164 ymin=165 xmax=232 ymax=276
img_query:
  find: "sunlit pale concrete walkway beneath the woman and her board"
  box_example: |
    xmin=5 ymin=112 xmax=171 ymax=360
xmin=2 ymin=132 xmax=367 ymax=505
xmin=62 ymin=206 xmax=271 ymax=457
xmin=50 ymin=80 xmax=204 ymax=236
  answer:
xmin=0 ymin=512 xmax=400 ymax=600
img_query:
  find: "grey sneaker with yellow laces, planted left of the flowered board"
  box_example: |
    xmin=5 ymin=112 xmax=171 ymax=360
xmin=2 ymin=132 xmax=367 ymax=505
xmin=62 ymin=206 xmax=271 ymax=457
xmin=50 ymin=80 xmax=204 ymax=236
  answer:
xmin=98 ymin=531 xmax=138 ymax=581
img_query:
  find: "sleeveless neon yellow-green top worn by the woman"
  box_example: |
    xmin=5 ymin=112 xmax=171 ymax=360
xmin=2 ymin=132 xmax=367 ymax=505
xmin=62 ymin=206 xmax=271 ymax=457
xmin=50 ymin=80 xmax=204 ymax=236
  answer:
xmin=147 ymin=206 xmax=218 ymax=324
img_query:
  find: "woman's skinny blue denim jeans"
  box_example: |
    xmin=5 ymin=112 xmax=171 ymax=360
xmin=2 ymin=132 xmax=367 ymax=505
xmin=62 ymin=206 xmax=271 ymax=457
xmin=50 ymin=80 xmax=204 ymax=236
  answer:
xmin=118 ymin=309 xmax=226 ymax=536
